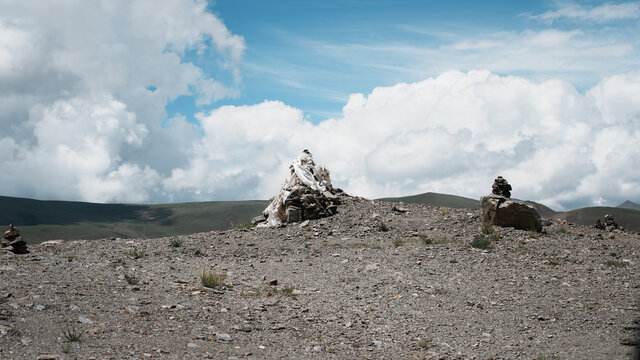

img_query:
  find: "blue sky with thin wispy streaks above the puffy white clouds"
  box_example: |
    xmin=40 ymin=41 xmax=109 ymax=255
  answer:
xmin=167 ymin=0 xmax=640 ymax=123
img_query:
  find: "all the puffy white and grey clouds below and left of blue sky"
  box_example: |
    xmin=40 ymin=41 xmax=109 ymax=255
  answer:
xmin=0 ymin=0 xmax=640 ymax=209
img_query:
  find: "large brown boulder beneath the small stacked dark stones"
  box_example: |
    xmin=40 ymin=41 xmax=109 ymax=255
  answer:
xmin=480 ymin=195 xmax=542 ymax=231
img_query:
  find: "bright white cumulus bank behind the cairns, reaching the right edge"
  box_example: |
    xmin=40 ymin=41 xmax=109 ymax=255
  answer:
xmin=166 ymin=71 xmax=640 ymax=209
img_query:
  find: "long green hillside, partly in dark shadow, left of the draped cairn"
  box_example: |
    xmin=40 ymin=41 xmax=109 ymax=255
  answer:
xmin=0 ymin=196 xmax=268 ymax=243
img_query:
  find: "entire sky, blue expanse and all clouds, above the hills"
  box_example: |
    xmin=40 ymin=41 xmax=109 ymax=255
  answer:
xmin=0 ymin=0 xmax=640 ymax=209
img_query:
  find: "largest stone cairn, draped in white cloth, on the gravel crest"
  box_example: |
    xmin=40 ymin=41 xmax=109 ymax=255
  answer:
xmin=251 ymin=150 xmax=345 ymax=226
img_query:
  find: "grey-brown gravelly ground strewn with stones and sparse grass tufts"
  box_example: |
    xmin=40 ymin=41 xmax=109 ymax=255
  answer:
xmin=0 ymin=198 xmax=640 ymax=359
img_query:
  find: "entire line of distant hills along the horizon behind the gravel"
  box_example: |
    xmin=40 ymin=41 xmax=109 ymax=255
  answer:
xmin=0 ymin=192 xmax=640 ymax=243
